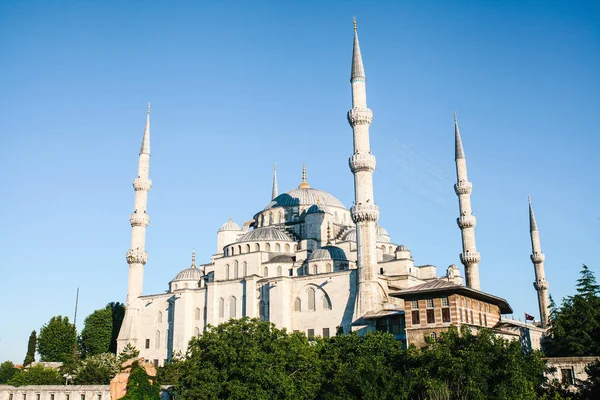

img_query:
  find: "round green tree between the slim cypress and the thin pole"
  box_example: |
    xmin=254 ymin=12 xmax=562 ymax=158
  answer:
xmin=37 ymin=315 xmax=77 ymax=362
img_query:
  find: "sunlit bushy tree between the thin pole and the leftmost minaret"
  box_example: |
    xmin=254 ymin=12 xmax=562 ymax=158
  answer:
xmin=79 ymin=305 xmax=113 ymax=357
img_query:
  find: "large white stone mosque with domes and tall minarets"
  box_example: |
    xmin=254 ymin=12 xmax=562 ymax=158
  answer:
xmin=118 ymin=22 xmax=548 ymax=365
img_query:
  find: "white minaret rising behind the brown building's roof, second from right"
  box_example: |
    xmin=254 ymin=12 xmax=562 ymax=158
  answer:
xmin=454 ymin=112 xmax=481 ymax=290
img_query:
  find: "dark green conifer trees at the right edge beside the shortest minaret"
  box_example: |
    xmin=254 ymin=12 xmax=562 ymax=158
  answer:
xmin=543 ymin=265 xmax=600 ymax=357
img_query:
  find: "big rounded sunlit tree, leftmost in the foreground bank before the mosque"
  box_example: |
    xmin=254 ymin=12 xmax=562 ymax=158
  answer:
xmin=176 ymin=318 xmax=321 ymax=400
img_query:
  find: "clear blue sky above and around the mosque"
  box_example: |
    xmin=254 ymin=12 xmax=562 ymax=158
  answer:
xmin=0 ymin=1 xmax=600 ymax=362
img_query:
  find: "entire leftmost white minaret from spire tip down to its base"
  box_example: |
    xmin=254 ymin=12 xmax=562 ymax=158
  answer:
xmin=117 ymin=104 xmax=152 ymax=352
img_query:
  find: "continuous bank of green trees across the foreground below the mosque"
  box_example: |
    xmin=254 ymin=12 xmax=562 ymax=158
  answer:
xmin=176 ymin=318 xmax=546 ymax=400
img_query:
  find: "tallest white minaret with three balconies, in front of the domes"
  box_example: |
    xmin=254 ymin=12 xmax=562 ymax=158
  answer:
xmin=348 ymin=19 xmax=384 ymax=318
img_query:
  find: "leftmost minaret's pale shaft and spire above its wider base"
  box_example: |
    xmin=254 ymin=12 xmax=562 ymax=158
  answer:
xmin=127 ymin=104 xmax=152 ymax=305
